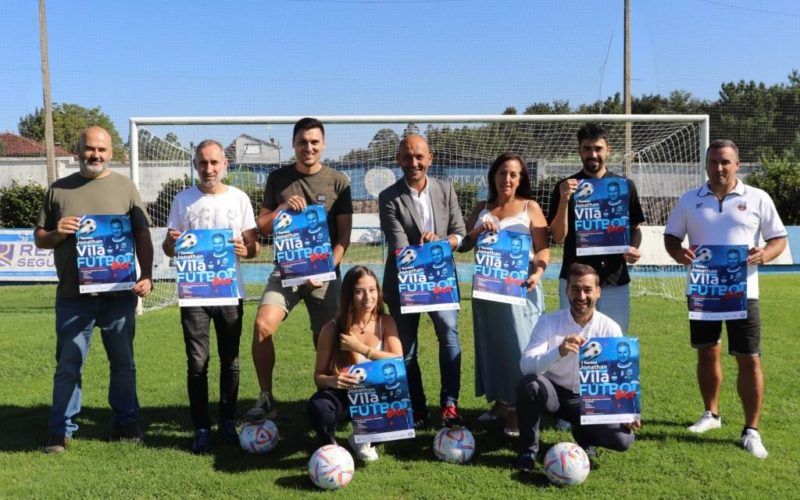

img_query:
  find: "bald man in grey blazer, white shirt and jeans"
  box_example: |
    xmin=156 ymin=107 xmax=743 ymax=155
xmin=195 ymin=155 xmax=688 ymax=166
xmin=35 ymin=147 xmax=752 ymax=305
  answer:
xmin=378 ymin=135 xmax=466 ymax=427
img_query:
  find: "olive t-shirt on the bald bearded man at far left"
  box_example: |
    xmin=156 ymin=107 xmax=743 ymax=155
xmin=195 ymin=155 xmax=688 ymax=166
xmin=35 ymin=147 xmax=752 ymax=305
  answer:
xmin=36 ymin=172 xmax=150 ymax=298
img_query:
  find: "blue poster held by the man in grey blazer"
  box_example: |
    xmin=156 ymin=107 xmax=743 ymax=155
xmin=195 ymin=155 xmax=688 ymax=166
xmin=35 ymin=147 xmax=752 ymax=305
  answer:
xmin=396 ymin=240 xmax=459 ymax=314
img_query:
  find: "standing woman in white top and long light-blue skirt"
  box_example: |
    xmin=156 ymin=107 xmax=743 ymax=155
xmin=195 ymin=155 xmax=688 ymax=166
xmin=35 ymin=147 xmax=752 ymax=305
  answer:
xmin=460 ymin=153 xmax=550 ymax=437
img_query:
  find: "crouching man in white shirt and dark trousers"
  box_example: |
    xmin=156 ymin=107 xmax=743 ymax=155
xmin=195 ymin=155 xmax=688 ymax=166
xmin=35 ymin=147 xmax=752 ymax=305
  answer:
xmin=516 ymin=262 xmax=641 ymax=471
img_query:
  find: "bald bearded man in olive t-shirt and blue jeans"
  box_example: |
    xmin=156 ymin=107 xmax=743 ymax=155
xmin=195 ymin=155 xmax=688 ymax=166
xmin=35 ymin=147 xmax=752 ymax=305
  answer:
xmin=34 ymin=127 xmax=153 ymax=453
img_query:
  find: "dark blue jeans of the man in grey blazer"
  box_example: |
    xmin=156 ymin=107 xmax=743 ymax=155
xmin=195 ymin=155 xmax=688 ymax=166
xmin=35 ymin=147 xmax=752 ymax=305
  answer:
xmin=389 ymin=298 xmax=461 ymax=420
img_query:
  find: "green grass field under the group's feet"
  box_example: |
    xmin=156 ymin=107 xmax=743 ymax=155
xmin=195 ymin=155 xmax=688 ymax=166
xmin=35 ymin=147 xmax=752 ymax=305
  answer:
xmin=0 ymin=276 xmax=800 ymax=499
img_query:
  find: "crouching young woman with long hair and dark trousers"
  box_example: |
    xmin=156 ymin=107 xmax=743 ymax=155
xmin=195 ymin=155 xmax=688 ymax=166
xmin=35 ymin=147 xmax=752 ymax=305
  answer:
xmin=308 ymin=266 xmax=403 ymax=461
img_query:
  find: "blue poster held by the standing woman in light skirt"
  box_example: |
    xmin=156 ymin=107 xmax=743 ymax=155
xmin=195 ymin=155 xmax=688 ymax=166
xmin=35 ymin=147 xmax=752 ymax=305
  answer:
xmin=472 ymin=229 xmax=531 ymax=305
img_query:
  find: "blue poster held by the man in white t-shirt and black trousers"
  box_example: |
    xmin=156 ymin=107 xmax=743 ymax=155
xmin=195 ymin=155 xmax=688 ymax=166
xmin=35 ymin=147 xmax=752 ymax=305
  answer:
xmin=175 ymin=229 xmax=240 ymax=307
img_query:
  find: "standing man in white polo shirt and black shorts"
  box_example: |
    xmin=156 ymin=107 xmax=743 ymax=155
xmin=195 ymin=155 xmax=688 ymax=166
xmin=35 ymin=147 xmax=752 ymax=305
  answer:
xmin=664 ymin=139 xmax=787 ymax=458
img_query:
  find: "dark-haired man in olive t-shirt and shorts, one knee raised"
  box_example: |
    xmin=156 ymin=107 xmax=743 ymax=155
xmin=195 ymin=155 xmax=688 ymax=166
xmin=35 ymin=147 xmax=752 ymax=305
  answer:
xmin=245 ymin=118 xmax=353 ymax=421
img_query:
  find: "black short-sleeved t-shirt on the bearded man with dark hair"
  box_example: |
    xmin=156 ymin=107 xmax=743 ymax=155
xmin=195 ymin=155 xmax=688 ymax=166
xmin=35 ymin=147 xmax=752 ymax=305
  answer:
xmin=547 ymin=170 xmax=644 ymax=286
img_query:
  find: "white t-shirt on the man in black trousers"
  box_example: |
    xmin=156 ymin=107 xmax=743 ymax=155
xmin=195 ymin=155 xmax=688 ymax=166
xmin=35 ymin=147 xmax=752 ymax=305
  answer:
xmin=167 ymin=186 xmax=256 ymax=297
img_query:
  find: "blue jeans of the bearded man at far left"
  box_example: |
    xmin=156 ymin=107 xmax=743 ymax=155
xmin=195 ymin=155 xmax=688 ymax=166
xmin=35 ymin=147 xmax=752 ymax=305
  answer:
xmin=49 ymin=293 xmax=139 ymax=437
